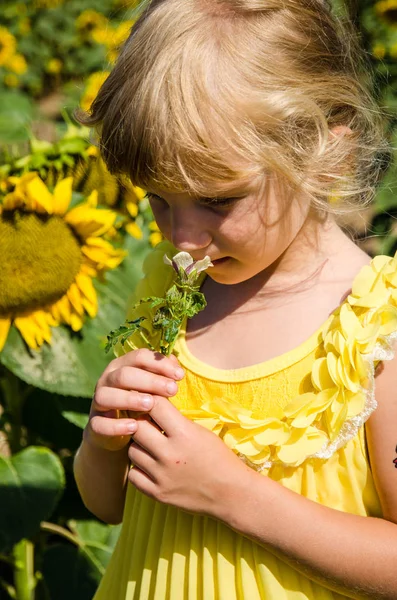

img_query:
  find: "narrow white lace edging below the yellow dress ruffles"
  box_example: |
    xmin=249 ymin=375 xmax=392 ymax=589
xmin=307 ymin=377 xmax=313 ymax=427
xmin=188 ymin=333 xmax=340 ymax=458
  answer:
xmin=238 ymin=331 xmax=397 ymax=473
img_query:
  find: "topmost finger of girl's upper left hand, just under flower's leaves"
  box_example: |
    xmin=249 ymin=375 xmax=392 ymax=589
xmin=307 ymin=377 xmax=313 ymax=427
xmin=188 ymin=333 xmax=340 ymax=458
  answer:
xmin=103 ymin=348 xmax=183 ymax=379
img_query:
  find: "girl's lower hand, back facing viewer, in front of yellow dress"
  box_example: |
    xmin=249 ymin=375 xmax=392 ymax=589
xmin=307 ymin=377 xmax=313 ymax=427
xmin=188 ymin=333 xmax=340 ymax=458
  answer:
xmin=128 ymin=397 xmax=250 ymax=518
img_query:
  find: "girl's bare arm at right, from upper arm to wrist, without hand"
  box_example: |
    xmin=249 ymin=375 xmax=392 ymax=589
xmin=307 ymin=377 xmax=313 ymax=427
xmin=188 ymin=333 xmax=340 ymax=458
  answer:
xmin=213 ymin=361 xmax=397 ymax=600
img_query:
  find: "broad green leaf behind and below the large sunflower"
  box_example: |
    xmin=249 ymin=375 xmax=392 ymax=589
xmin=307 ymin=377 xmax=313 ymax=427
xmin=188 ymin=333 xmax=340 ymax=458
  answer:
xmin=0 ymin=238 xmax=149 ymax=397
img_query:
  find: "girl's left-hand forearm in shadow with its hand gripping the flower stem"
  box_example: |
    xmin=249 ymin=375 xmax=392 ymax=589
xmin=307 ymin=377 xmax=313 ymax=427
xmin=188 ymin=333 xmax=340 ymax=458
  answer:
xmin=74 ymin=348 xmax=183 ymax=524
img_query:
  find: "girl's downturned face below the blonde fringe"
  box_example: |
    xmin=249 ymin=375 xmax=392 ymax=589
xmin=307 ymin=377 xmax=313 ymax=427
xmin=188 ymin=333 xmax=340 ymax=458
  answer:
xmin=148 ymin=180 xmax=309 ymax=284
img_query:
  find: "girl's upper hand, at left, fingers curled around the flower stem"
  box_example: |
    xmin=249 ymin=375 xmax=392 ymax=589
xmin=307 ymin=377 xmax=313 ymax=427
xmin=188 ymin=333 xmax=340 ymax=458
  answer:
xmin=84 ymin=348 xmax=183 ymax=451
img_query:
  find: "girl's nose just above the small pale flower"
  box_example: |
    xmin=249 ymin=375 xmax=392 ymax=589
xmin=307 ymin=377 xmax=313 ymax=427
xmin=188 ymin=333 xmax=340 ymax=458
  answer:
xmin=170 ymin=211 xmax=212 ymax=252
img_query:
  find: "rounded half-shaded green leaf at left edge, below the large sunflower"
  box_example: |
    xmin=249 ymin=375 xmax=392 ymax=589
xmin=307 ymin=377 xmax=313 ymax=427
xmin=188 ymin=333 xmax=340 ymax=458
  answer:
xmin=0 ymin=446 xmax=65 ymax=552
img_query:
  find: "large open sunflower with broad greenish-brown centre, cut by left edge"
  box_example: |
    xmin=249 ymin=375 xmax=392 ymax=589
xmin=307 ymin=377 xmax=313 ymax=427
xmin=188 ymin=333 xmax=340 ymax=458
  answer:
xmin=0 ymin=172 xmax=126 ymax=350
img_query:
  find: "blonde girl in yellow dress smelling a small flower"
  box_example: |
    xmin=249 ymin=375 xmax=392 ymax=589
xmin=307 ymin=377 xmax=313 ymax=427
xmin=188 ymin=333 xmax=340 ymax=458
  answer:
xmin=75 ymin=0 xmax=397 ymax=600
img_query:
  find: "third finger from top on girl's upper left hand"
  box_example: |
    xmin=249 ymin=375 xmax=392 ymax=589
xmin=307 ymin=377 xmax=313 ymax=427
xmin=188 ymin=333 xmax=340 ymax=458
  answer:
xmin=93 ymin=386 xmax=154 ymax=412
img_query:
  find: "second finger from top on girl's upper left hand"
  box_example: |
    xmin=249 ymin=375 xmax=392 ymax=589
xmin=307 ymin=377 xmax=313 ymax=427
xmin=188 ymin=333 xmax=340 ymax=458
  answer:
xmin=104 ymin=367 xmax=178 ymax=397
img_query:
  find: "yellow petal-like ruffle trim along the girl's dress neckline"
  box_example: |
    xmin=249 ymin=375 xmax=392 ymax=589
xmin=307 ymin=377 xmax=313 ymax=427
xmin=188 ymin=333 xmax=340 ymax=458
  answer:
xmin=117 ymin=242 xmax=397 ymax=471
